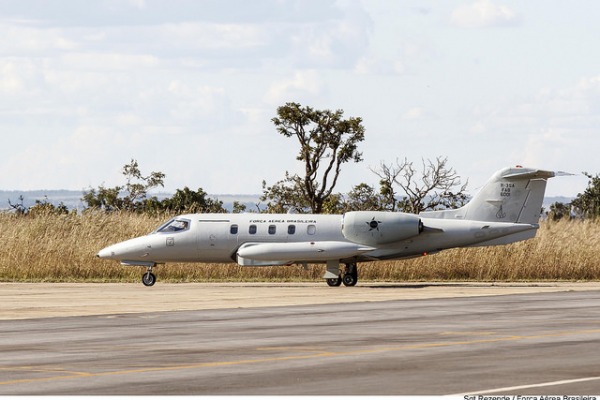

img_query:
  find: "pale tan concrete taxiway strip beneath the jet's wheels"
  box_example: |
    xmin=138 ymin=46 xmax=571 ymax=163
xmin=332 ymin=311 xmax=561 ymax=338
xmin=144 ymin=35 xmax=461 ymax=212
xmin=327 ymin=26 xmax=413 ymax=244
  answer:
xmin=0 ymin=282 xmax=600 ymax=320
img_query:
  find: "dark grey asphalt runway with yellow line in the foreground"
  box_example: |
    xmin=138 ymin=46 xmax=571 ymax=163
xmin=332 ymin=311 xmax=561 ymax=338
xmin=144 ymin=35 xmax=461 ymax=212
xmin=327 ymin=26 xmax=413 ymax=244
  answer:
xmin=0 ymin=285 xmax=600 ymax=396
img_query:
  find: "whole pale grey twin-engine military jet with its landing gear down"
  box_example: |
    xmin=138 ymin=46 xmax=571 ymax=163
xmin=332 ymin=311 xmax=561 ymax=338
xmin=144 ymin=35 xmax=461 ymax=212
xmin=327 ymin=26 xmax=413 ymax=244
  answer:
xmin=97 ymin=166 xmax=556 ymax=286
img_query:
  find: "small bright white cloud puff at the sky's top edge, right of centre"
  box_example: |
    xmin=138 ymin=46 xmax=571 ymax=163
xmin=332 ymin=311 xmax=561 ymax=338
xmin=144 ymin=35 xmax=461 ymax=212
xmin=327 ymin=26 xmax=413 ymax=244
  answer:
xmin=450 ymin=0 xmax=519 ymax=28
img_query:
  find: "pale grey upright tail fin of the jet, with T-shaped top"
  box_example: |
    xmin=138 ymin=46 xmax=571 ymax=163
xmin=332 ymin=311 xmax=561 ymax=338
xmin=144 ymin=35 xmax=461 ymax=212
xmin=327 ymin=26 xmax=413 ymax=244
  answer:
xmin=421 ymin=166 xmax=556 ymax=225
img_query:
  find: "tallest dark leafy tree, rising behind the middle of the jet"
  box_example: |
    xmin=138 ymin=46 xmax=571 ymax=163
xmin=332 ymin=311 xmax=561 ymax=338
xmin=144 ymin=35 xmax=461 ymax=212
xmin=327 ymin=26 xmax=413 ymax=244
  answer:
xmin=261 ymin=103 xmax=365 ymax=214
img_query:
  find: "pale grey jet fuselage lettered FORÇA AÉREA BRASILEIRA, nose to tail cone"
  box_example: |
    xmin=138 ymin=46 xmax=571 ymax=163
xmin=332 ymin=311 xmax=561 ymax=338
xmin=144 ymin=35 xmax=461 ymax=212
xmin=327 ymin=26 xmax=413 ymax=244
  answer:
xmin=99 ymin=211 xmax=537 ymax=266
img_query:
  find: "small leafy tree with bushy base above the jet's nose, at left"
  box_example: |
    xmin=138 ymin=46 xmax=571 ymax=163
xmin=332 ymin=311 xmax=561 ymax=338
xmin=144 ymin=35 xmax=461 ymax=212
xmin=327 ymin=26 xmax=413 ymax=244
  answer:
xmin=82 ymin=159 xmax=165 ymax=211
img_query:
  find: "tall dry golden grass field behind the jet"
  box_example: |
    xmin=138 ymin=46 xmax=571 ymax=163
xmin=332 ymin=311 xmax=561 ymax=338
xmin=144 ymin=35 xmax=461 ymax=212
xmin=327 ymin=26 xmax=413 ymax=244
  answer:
xmin=0 ymin=213 xmax=600 ymax=282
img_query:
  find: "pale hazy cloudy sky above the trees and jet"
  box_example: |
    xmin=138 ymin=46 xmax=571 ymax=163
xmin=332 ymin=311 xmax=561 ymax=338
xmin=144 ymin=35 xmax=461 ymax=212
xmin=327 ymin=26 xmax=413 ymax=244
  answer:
xmin=0 ymin=0 xmax=600 ymax=196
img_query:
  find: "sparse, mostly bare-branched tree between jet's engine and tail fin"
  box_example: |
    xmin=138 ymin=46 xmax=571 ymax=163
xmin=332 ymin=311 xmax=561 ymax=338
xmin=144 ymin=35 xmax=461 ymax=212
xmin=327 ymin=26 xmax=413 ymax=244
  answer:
xmin=372 ymin=157 xmax=468 ymax=214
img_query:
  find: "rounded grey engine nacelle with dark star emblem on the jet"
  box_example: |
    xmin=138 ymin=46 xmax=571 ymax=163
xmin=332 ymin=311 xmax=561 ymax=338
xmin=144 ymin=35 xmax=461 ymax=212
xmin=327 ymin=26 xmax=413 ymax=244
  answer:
xmin=342 ymin=211 xmax=423 ymax=246
